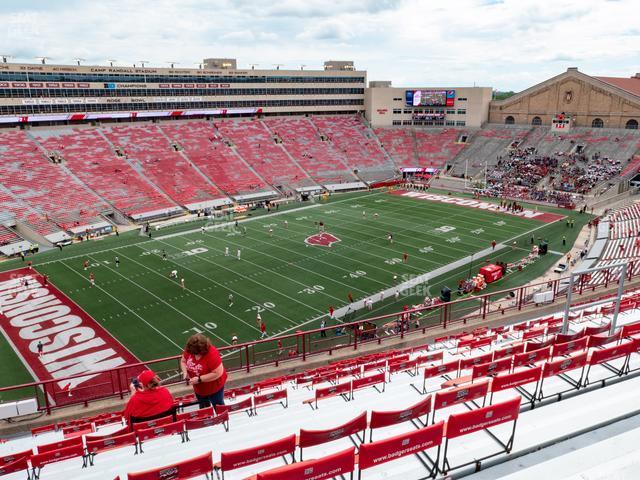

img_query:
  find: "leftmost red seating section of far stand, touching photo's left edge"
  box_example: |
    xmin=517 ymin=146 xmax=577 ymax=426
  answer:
xmin=0 ymin=131 xmax=107 ymax=235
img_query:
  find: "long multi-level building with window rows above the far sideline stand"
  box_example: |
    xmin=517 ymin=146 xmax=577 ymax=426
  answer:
xmin=0 ymin=58 xmax=366 ymax=124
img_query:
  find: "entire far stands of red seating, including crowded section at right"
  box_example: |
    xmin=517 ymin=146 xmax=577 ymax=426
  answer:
xmin=0 ymin=115 xmax=640 ymax=235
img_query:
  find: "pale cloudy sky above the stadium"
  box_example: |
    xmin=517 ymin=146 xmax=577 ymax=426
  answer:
xmin=0 ymin=0 xmax=640 ymax=91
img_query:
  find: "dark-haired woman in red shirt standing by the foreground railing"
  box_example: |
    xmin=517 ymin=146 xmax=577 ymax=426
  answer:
xmin=180 ymin=333 xmax=227 ymax=408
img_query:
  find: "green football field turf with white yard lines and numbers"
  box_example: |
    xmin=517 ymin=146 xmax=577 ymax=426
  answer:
xmin=0 ymin=192 xmax=590 ymax=385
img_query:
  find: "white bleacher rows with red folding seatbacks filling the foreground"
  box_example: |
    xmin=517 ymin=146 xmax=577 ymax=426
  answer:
xmin=0 ymin=294 xmax=640 ymax=480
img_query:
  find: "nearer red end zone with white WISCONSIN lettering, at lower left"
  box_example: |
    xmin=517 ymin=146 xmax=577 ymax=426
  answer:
xmin=0 ymin=268 xmax=139 ymax=405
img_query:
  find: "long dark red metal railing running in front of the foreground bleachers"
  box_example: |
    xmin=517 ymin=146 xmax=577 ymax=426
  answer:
xmin=0 ymin=262 xmax=640 ymax=414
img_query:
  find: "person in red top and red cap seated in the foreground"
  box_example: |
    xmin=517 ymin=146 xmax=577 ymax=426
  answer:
xmin=123 ymin=370 xmax=173 ymax=425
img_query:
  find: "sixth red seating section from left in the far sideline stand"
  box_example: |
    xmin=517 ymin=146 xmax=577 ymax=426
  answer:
xmin=264 ymin=117 xmax=356 ymax=184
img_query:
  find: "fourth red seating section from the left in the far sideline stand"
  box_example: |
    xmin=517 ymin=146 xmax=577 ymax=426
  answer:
xmin=160 ymin=121 xmax=267 ymax=195
